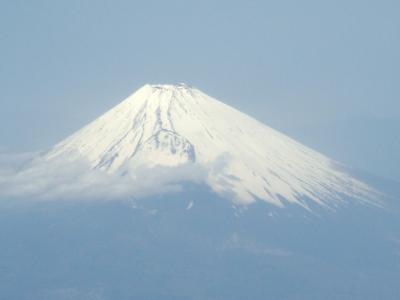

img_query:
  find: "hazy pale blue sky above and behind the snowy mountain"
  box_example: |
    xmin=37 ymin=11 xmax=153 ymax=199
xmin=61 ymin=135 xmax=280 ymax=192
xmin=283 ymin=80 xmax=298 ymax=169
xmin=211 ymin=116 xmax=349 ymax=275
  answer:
xmin=0 ymin=0 xmax=400 ymax=180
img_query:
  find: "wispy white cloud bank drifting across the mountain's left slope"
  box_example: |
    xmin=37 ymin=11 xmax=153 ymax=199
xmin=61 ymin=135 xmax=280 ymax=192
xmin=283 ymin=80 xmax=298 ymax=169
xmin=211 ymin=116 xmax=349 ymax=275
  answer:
xmin=0 ymin=152 xmax=212 ymax=200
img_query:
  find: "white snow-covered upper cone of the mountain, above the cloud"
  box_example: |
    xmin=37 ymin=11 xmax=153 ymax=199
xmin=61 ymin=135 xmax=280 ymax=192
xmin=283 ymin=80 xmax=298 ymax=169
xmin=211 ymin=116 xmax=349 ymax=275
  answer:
xmin=39 ymin=84 xmax=373 ymax=206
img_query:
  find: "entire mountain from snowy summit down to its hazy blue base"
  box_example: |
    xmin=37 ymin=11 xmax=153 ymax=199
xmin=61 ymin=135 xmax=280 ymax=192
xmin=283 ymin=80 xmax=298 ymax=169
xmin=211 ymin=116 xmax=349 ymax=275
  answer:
xmin=0 ymin=84 xmax=400 ymax=300
